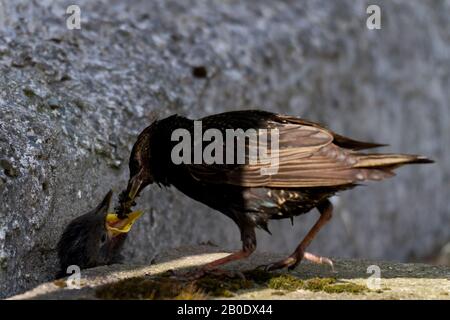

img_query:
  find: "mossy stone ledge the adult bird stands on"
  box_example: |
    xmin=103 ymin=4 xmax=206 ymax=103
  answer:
xmin=13 ymin=246 xmax=450 ymax=300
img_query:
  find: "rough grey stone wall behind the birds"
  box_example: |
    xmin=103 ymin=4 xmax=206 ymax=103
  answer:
xmin=0 ymin=0 xmax=450 ymax=297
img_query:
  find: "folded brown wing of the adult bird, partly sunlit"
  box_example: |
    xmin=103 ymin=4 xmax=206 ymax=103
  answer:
xmin=187 ymin=114 xmax=378 ymax=188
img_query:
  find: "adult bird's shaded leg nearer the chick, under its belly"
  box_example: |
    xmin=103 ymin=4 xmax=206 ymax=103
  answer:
xmin=179 ymin=226 xmax=256 ymax=278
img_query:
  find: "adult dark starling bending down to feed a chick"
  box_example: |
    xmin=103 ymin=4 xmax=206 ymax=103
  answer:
xmin=116 ymin=110 xmax=432 ymax=270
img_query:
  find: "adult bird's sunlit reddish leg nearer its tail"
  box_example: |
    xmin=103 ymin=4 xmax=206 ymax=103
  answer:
xmin=266 ymin=199 xmax=333 ymax=271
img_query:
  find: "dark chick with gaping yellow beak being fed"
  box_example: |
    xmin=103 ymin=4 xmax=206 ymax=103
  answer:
xmin=57 ymin=191 xmax=141 ymax=276
